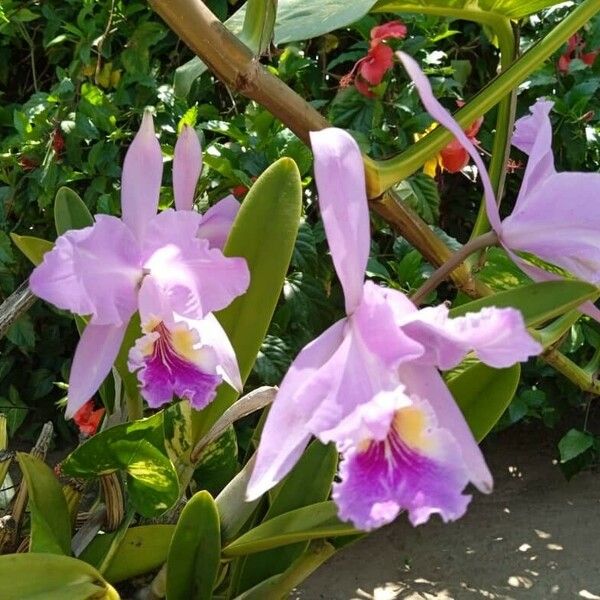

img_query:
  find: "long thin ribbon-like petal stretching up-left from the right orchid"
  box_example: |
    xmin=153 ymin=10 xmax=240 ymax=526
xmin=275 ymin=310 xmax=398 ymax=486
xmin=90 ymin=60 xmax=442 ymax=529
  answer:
xmin=397 ymin=52 xmax=500 ymax=231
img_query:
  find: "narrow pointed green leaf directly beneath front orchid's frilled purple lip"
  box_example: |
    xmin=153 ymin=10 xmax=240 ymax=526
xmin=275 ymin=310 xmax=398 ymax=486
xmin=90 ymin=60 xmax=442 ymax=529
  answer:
xmin=223 ymin=501 xmax=360 ymax=558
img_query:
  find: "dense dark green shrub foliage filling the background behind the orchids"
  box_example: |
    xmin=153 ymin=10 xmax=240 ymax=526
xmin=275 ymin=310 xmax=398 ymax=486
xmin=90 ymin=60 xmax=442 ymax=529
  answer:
xmin=0 ymin=0 xmax=600 ymax=474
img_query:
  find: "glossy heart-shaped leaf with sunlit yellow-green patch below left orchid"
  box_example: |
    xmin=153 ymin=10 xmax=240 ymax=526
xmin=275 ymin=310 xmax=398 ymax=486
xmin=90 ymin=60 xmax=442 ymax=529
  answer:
xmin=62 ymin=413 xmax=179 ymax=518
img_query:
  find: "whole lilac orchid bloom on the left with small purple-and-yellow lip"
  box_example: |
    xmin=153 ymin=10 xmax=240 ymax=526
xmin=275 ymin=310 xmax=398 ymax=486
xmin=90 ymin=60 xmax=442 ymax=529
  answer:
xmin=29 ymin=113 xmax=249 ymax=416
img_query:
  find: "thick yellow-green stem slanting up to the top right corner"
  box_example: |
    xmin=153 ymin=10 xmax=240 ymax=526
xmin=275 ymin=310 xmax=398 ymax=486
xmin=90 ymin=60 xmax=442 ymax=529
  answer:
xmin=366 ymin=0 xmax=600 ymax=198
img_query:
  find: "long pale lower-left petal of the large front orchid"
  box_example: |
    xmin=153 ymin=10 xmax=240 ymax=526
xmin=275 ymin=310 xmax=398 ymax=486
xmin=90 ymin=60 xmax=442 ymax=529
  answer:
xmin=246 ymin=319 xmax=347 ymax=501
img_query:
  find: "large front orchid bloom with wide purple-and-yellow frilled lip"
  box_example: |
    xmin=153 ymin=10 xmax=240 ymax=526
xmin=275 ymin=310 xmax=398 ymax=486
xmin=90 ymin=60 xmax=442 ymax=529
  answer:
xmin=247 ymin=129 xmax=541 ymax=530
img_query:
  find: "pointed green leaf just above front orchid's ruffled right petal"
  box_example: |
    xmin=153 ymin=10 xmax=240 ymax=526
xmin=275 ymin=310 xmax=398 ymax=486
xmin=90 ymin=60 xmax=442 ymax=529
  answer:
xmin=450 ymin=280 xmax=600 ymax=327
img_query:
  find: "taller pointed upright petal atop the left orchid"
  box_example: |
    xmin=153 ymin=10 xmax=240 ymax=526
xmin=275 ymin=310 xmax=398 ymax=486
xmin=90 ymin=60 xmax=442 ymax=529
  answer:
xmin=121 ymin=111 xmax=163 ymax=241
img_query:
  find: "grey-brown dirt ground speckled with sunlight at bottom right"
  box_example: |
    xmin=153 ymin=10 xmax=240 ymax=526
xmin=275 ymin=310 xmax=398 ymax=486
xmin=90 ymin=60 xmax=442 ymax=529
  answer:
xmin=292 ymin=428 xmax=600 ymax=600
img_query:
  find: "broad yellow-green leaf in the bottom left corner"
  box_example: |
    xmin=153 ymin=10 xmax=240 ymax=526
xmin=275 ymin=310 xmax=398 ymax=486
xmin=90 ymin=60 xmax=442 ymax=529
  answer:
xmin=0 ymin=552 xmax=119 ymax=600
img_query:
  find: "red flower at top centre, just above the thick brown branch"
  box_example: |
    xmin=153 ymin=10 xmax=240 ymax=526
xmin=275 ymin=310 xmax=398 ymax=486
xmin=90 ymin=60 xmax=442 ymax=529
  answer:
xmin=341 ymin=21 xmax=408 ymax=98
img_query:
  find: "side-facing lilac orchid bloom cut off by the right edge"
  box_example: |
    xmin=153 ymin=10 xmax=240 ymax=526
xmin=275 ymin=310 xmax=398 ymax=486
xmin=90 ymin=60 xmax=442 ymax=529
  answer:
xmin=398 ymin=52 xmax=600 ymax=320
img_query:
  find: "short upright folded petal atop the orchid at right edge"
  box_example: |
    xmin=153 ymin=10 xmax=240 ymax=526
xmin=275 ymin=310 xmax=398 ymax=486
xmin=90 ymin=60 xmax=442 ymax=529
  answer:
xmin=512 ymin=100 xmax=556 ymax=202
